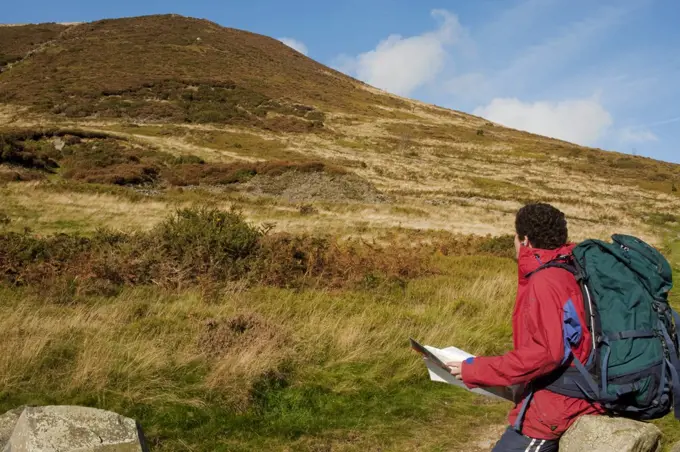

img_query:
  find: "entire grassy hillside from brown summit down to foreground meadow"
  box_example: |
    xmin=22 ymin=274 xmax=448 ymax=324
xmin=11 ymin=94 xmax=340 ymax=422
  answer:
xmin=0 ymin=15 xmax=680 ymax=452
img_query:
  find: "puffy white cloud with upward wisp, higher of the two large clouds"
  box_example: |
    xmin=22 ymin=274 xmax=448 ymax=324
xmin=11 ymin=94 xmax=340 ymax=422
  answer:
xmin=335 ymin=10 xmax=466 ymax=96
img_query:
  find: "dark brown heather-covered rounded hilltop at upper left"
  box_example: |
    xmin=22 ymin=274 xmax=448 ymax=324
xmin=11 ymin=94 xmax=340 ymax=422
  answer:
xmin=0 ymin=15 xmax=412 ymax=129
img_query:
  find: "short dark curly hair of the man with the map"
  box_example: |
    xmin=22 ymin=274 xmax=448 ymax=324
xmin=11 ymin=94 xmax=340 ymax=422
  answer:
xmin=515 ymin=203 xmax=568 ymax=250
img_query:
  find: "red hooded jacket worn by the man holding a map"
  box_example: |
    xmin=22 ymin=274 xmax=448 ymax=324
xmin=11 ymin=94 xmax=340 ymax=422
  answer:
xmin=462 ymin=245 xmax=602 ymax=440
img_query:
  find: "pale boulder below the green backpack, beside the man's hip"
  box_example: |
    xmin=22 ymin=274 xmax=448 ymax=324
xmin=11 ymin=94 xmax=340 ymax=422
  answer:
xmin=560 ymin=416 xmax=661 ymax=452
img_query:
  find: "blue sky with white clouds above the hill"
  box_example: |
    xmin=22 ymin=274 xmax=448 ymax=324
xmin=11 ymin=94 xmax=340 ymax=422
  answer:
xmin=5 ymin=0 xmax=680 ymax=162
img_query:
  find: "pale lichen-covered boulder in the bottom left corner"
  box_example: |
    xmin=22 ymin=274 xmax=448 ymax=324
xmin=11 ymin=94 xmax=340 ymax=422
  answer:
xmin=0 ymin=406 xmax=148 ymax=452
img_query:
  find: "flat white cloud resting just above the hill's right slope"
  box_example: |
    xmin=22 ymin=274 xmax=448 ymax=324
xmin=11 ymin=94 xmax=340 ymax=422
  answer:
xmin=474 ymin=98 xmax=613 ymax=145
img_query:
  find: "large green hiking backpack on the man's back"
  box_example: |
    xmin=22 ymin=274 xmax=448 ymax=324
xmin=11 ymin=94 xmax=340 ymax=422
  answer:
xmin=525 ymin=235 xmax=680 ymax=420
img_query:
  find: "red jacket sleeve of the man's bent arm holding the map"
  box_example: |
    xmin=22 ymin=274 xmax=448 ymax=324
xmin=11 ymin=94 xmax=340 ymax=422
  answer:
xmin=462 ymin=278 xmax=566 ymax=388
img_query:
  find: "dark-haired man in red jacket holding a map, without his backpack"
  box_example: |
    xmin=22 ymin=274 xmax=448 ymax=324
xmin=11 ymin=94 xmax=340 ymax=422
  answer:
xmin=447 ymin=203 xmax=604 ymax=452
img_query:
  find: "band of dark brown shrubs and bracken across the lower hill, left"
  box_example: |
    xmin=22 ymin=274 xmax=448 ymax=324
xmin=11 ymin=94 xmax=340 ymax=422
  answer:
xmin=0 ymin=129 xmax=356 ymax=192
